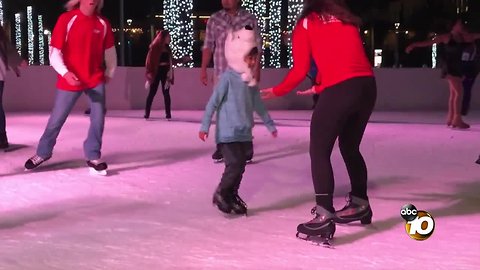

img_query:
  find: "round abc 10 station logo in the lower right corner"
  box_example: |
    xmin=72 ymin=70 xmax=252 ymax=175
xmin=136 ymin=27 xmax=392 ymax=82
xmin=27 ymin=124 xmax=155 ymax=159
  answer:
xmin=400 ymin=204 xmax=435 ymax=241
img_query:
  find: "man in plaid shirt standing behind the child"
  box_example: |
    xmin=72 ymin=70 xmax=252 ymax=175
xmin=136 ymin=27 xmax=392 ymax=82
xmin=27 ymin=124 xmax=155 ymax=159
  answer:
xmin=200 ymin=0 xmax=263 ymax=162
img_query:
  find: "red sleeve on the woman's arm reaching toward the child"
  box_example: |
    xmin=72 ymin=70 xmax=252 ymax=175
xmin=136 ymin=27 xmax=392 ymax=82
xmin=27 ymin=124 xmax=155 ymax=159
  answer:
xmin=273 ymin=20 xmax=312 ymax=96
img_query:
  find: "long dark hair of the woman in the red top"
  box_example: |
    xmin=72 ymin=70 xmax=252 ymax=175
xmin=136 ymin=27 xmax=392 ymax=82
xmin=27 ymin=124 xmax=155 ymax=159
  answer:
xmin=299 ymin=0 xmax=361 ymax=26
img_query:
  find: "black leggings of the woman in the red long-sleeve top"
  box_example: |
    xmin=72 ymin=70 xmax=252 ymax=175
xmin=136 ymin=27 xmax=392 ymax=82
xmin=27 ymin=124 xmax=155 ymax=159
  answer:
xmin=310 ymin=77 xmax=377 ymax=212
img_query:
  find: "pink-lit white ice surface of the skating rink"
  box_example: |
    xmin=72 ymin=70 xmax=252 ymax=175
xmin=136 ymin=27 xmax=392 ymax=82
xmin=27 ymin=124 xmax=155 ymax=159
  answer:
xmin=0 ymin=111 xmax=480 ymax=270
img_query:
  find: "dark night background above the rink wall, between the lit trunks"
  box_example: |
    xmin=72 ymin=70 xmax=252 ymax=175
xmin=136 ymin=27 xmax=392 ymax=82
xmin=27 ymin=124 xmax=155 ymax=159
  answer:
xmin=3 ymin=0 xmax=480 ymax=67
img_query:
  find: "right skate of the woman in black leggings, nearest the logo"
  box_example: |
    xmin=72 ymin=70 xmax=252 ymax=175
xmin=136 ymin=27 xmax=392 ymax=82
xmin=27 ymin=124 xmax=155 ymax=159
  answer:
xmin=334 ymin=193 xmax=373 ymax=224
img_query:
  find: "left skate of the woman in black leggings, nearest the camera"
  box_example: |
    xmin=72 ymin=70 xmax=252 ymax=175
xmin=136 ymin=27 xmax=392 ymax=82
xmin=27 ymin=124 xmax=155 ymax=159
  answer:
xmin=296 ymin=205 xmax=335 ymax=246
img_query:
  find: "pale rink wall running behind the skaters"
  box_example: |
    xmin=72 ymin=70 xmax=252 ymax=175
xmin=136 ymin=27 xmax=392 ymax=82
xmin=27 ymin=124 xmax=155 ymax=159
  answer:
xmin=3 ymin=66 xmax=466 ymax=112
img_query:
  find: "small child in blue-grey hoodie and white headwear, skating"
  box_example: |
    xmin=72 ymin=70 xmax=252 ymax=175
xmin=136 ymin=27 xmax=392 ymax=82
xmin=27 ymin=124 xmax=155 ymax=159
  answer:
xmin=199 ymin=26 xmax=277 ymax=214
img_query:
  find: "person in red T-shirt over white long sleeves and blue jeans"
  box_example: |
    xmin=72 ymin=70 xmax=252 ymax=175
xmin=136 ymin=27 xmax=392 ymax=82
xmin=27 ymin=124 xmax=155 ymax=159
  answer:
xmin=25 ymin=0 xmax=117 ymax=174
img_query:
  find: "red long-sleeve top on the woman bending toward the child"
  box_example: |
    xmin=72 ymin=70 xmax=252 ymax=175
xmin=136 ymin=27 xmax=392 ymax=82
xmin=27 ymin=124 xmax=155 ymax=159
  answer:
xmin=273 ymin=14 xmax=373 ymax=96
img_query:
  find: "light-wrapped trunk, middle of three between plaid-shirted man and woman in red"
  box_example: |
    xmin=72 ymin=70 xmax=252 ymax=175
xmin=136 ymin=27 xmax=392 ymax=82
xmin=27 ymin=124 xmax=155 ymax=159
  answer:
xmin=268 ymin=0 xmax=282 ymax=68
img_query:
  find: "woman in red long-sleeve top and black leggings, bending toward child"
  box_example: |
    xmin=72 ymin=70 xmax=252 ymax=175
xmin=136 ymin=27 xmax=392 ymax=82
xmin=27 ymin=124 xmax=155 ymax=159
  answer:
xmin=262 ymin=0 xmax=377 ymax=239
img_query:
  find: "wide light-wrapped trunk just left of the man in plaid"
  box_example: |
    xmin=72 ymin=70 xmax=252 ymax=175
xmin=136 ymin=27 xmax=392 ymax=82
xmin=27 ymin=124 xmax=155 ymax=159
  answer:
xmin=163 ymin=0 xmax=194 ymax=67
